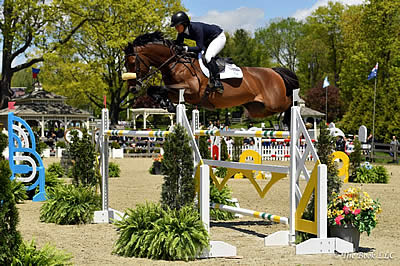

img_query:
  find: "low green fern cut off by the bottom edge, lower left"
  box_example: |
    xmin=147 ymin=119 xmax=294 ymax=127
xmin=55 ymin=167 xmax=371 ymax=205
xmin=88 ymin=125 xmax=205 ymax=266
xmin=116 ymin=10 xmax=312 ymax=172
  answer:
xmin=11 ymin=240 xmax=72 ymax=266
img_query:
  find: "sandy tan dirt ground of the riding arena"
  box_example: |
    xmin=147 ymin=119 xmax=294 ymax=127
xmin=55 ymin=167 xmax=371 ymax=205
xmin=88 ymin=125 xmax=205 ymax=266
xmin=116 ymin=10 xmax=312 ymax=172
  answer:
xmin=18 ymin=158 xmax=400 ymax=265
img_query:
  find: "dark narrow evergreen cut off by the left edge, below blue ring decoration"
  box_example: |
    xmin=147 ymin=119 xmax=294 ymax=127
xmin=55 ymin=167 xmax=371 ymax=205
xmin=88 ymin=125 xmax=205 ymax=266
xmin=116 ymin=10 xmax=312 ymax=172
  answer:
xmin=0 ymin=159 xmax=22 ymax=265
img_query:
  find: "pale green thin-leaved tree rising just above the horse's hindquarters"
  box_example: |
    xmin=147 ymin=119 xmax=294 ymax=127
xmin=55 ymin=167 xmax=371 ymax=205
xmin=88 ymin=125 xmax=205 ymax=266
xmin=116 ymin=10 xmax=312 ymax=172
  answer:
xmin=255 ymin=17 xmax=302 ymax=72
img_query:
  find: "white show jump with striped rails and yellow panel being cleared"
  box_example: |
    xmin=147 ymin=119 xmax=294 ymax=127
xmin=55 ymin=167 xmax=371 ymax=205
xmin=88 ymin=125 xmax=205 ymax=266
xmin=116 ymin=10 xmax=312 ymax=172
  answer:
xmin=98 ymin=90 xmax=353 ymax=257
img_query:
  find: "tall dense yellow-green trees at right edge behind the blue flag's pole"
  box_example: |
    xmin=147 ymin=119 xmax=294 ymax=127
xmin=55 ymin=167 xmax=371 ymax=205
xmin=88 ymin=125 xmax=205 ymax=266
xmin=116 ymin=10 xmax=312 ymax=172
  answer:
xmin=340 ymin=0 xmax=400 ymax=141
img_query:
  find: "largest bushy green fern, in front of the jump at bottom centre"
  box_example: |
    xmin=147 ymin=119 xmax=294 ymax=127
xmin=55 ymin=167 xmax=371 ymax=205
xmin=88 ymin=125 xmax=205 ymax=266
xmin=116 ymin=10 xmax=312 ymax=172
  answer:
xmin=113 ymin=203 xmax=209 ymax=261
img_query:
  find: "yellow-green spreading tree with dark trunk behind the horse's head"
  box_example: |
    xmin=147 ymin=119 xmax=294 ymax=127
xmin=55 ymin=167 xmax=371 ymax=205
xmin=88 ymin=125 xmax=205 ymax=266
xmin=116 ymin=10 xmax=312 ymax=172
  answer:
xmin=42 ymin=0 xmax=183 ymax=123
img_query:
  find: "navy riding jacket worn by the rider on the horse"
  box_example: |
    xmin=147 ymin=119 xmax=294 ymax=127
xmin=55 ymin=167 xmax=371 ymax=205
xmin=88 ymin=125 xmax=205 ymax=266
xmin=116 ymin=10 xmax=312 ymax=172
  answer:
xmin=176 ymin=22 xmax=223 ymax=53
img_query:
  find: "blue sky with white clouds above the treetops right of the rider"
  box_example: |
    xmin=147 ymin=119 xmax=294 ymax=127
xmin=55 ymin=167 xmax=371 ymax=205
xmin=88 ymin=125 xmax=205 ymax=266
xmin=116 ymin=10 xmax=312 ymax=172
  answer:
xmin=182 ymin=0 xmax=364 ymax=33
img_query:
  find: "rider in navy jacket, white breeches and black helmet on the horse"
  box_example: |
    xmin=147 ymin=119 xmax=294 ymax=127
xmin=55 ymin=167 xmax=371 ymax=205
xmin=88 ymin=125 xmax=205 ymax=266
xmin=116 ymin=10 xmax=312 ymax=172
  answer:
xmin=171 ymin=11 xmax=226 ymax=93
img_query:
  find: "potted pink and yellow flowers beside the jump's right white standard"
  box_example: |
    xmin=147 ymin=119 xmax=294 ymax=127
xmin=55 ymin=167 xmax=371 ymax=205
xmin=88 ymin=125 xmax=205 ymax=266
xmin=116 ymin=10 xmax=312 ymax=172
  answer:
xmin=328 ymin=188 xmax=381 ymax=251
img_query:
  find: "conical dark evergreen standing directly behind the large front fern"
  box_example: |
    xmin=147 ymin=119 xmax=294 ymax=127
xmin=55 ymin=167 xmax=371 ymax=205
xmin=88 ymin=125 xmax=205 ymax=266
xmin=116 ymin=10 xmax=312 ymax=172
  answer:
xmin=161 ymin=124 xmax=195 ymax=210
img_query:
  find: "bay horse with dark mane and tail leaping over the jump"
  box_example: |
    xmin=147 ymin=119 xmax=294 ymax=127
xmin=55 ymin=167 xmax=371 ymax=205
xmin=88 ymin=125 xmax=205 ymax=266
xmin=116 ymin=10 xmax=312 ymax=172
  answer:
xmin=124 ymin=32 xmax=299 ymax=127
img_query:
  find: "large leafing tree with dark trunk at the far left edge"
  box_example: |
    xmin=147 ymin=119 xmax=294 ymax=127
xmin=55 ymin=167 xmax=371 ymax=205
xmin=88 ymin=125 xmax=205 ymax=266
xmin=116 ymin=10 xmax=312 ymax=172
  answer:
xmin=0 ymin=0 xmax=103 ymax=108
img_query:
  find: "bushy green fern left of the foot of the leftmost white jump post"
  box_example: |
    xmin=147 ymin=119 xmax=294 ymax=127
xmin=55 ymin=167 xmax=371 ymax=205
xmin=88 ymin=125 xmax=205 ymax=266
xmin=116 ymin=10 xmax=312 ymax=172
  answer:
xmin=40 ymin=185 xmax=101 ymax=224
